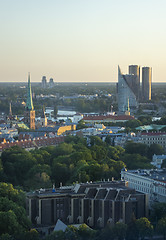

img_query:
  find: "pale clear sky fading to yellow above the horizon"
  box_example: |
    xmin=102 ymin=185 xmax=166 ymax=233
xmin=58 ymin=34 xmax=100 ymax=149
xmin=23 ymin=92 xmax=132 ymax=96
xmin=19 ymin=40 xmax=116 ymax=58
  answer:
xmin=0 ymin=0 xmax=166 ymax=82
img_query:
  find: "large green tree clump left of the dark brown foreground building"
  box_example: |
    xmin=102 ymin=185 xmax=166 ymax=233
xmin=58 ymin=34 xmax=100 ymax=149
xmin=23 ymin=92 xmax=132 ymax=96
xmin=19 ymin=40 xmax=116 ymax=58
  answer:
xmin=0 ymin=183 xmax=31 ymax=238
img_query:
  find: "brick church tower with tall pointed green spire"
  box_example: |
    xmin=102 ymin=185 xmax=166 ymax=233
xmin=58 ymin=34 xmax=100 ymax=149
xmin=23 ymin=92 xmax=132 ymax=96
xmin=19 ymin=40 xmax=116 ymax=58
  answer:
xmin=24 ymin=74 xmax=35 ymax=129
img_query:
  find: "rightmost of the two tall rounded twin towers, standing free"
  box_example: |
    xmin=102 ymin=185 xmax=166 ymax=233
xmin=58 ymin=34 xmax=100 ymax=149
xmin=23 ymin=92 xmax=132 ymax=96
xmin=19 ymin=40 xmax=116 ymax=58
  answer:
xmin=142 ymin=67 xmax=152 ymax=100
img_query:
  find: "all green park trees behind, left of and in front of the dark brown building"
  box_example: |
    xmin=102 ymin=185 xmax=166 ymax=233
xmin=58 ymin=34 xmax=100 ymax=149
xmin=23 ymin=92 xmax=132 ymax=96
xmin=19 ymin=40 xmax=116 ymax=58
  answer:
xmin=0 ymin=136 xmax=166 ymax=240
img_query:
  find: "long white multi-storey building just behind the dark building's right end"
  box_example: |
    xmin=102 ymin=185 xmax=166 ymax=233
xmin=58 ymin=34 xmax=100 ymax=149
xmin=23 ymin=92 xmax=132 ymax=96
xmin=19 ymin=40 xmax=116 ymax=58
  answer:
xmin=121 ymin=169 xmax=166 ymax=204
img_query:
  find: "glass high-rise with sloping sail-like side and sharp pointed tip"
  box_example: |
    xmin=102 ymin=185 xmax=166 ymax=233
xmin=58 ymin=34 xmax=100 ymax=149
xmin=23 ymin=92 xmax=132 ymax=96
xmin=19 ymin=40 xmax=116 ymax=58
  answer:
xmin=117 ymin=66 xmax=138 ymax=114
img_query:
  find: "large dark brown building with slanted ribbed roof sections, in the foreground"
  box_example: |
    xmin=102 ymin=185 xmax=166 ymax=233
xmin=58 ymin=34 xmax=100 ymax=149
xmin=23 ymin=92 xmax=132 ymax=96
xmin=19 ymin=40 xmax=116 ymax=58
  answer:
xmin=27 ymin=181 xmax=148 ymax=228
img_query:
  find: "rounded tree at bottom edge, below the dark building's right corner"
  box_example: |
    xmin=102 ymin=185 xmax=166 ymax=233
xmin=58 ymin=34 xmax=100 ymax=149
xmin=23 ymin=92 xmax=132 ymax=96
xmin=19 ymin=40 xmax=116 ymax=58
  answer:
xmin=136 ymin=217 xmax=153 ymax=240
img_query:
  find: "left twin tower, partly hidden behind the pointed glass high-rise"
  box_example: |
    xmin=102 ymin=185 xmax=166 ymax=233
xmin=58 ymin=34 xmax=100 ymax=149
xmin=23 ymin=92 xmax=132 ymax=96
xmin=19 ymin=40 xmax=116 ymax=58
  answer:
xmin=129 ymin=65 xmax=140 ymax=99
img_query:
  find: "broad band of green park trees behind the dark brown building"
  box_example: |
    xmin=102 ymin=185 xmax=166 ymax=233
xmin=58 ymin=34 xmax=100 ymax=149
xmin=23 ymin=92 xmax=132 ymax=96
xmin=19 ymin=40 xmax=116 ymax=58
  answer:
xmin=0 ymin=136 xmax=163 ymax=191
